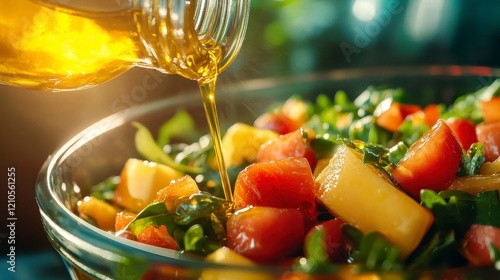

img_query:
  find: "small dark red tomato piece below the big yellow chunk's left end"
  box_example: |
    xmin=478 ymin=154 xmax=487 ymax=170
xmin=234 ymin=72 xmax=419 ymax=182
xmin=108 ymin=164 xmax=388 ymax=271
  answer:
xmin=305 ymin=218 xmax=348 ymax=262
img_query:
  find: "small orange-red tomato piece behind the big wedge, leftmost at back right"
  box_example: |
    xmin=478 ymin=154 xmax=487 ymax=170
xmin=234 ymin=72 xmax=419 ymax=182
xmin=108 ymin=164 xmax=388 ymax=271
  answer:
xmin=376 ymin=102 xmax=420 ymax=132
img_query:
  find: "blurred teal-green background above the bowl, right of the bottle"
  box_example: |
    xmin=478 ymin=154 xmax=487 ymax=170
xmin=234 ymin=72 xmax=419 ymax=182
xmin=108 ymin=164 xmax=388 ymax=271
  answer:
xmin=232 ymin=0 xmax=500 ymax=76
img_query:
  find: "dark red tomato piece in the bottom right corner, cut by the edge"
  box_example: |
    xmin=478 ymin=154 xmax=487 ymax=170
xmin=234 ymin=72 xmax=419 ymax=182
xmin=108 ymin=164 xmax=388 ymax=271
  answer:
xmin=462 ymin=224 xmax=500 ymax=265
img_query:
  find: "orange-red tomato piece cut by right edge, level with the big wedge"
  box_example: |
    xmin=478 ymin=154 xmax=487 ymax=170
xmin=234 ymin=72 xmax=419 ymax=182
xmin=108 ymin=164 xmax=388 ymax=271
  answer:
xmin=476 ymin=122 xmax=500 ymax=162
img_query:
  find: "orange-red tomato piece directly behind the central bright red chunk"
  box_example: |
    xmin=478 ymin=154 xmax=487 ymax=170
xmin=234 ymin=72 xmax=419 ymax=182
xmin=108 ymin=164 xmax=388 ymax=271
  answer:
xmin=256 ymin=129 xmax=316 ymax=169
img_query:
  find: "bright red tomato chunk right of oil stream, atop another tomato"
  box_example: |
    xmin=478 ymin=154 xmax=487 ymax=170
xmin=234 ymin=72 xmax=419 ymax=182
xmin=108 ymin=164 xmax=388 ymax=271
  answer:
xmin=234 ymin=158 xmax=316 ymax=224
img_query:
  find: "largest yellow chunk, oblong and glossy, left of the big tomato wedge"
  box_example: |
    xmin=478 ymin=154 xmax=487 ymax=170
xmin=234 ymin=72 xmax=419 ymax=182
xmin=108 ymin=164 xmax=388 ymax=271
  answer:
xmin=316 ymin=146 xmax=434 ymax=258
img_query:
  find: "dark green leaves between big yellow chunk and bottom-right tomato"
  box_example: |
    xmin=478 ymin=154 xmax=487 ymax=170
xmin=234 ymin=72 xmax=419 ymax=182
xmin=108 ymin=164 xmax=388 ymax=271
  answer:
xmin=414 ymin=190 xmax=500 ymax=269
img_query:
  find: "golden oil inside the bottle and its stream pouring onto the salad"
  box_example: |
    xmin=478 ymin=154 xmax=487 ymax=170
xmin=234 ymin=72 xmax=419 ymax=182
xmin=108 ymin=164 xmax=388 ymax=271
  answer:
xmin=0 ymin=0 xmax=236 ymax=201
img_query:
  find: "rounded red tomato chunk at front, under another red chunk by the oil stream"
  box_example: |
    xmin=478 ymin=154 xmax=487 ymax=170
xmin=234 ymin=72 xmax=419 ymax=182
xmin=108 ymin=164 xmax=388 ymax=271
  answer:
xmin=227 ymin=206 xmax=305 ymax=263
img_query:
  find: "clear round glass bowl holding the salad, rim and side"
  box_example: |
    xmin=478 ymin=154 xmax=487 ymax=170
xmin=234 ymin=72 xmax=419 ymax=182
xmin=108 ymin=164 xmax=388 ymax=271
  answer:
xmin=36 ymin=66 xmax=500 ymax=279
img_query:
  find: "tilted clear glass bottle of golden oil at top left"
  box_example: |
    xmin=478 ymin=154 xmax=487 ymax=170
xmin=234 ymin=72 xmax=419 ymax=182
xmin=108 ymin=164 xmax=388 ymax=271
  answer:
xmin=0 ymin=0 xmax=250 ymax=91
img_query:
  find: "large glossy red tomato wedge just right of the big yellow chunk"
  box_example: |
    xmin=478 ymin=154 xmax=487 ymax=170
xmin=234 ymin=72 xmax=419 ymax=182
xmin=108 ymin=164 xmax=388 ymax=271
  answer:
xmin=392 ymin=119 xmax=462 ymax=199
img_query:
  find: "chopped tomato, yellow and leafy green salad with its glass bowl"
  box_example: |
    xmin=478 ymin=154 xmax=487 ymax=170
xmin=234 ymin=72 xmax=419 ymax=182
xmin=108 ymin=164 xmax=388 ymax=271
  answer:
xmin=37 ymin=67 xmax=500 ymax=279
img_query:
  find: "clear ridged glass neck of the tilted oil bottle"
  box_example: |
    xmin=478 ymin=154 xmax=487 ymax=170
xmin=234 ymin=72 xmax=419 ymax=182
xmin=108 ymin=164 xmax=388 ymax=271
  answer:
xmin=132 ymin=0 xmax=250 ymax=80
